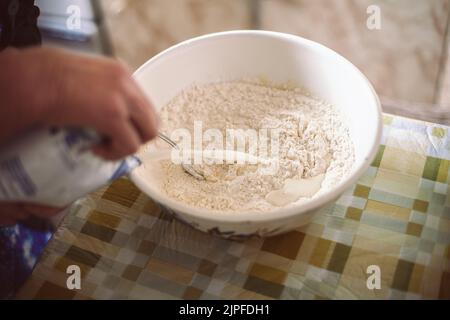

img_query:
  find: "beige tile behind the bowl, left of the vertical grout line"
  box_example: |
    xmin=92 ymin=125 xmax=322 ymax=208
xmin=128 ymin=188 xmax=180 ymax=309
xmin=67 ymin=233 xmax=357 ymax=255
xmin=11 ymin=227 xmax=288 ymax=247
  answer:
xmin=101 ymin=0 xmax=250 ymax=69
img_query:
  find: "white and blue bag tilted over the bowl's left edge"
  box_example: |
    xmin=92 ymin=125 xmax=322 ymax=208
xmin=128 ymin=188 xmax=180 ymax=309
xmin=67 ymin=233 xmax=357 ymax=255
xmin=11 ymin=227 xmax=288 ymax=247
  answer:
xmin=0 ymin=129 xmax=140 ymax=207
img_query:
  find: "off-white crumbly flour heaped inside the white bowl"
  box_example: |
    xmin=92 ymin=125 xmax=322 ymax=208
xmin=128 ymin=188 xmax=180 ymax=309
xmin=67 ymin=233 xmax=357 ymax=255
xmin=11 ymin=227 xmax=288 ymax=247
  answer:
xmin=155 ymin=81 xmax=354 ymax=212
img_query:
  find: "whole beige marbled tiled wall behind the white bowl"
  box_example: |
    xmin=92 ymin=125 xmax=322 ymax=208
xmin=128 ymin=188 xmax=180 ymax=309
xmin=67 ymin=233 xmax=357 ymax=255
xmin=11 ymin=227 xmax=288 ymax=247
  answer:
xmin=102 ymin=0 xmax=450 ymax=121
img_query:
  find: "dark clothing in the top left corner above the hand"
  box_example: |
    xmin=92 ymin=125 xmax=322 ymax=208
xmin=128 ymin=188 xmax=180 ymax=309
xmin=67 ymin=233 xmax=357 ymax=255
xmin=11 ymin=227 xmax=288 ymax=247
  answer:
xmin=0 ymin=0 xmax=41 ymax=50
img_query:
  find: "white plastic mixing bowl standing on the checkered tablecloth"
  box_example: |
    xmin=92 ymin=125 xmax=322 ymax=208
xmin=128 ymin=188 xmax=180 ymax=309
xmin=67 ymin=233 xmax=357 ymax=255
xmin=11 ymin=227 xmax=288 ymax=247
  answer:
xmin=131 ymin=31 xmax=382 ymax=238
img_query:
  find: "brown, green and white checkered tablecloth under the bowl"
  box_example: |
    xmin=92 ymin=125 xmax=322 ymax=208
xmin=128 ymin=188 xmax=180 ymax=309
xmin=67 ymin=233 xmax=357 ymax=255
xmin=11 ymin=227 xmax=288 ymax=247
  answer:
xmin=17 ymin=115 xmax=450 ymax=299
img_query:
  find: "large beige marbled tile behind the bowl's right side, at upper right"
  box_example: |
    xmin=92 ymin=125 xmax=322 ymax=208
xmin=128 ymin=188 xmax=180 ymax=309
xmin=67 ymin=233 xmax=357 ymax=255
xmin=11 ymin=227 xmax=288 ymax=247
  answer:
xmin=260 ymin=0 xmax=449 ymax=102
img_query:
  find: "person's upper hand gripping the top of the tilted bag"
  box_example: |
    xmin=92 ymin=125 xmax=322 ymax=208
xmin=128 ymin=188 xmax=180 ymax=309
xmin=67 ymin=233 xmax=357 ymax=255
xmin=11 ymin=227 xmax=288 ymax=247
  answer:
xmin=0 ymin=48 xmax=158 ymax=160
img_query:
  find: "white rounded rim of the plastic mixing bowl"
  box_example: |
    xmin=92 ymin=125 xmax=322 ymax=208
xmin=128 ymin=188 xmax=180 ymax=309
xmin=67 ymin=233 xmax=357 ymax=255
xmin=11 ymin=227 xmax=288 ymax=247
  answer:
xmin=129 ymin=30 xmax=383 ymax=223
